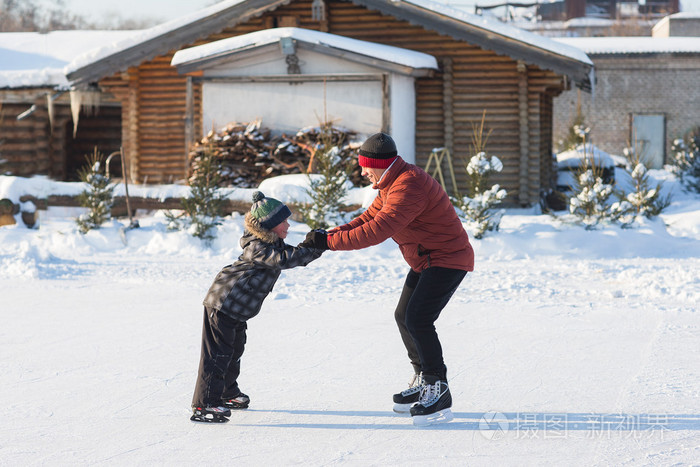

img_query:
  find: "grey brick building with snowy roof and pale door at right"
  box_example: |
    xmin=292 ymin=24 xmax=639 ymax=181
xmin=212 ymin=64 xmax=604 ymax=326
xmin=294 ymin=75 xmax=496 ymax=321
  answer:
xmin=554 ymin=13 xmax=700 ymax=168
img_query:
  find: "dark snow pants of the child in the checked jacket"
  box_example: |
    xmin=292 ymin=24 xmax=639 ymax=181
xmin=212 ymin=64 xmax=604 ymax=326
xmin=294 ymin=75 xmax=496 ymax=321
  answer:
xmin=192 ymin=307 xmax=248 ymax=407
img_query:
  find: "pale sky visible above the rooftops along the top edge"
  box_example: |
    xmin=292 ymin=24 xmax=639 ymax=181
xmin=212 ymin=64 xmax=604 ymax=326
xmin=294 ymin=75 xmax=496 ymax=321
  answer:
xmin=42 ymin=0 xmax=700 ymax=25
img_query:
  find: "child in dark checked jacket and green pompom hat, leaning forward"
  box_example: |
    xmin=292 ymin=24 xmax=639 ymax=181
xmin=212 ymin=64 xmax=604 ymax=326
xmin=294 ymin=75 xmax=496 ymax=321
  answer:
xmin=190 ymin=191 xmax=322 ymax=422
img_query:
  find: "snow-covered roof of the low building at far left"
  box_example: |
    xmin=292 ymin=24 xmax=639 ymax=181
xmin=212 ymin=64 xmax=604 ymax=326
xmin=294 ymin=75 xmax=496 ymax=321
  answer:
xmin=0 ymin=31 xmax=135 ymax=88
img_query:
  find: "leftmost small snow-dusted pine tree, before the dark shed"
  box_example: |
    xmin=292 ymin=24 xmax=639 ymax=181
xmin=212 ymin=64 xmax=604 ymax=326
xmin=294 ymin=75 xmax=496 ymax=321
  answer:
xmin=76 ymin=148 xmax=114 ymax=234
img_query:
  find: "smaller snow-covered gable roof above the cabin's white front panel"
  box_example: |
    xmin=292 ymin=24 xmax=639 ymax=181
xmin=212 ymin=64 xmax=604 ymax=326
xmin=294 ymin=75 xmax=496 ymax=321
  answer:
xmin=172 ymin=28 xmax=438 ymax=70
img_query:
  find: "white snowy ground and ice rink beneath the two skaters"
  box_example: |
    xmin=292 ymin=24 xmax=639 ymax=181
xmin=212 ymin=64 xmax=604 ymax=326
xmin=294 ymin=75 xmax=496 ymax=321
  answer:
xmin=0 ymin=177 xmax=700 ymax=466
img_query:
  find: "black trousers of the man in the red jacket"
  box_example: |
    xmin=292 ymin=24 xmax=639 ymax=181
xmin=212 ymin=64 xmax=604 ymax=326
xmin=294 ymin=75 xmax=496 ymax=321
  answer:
xmin=394 ymin=267 xmax=467 ymax=381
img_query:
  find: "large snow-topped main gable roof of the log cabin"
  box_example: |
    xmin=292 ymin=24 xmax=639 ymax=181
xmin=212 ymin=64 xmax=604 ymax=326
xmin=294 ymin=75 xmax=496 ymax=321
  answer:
xmin=66 ymin=0 xmax=593 ymax=85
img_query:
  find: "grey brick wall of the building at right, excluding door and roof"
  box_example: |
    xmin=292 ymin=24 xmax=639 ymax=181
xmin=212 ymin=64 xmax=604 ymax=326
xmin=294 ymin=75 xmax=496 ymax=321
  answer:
xmin=554 ymin=53 xmax=700 ymax=160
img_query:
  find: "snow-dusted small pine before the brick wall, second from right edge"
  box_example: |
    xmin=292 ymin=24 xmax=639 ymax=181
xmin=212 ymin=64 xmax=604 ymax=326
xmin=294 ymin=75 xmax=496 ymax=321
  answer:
xmin=611 ymin=148 xmax=671 ymax=227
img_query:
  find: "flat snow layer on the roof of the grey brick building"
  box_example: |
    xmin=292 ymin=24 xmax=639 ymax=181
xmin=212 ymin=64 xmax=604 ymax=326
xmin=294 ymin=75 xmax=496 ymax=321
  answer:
xmin=556 ymin=36 xmax=700 ymax=55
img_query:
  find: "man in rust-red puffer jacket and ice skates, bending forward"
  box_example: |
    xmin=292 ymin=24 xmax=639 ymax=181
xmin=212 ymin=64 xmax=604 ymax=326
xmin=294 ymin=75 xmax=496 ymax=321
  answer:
xmin=302 ymin=133 xmax=474 ymax=425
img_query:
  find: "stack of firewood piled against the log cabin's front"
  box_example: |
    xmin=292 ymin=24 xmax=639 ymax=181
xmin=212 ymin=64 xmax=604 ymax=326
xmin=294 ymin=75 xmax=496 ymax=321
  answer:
xmin=189 ymin=120 xmax=367 ymax=188
